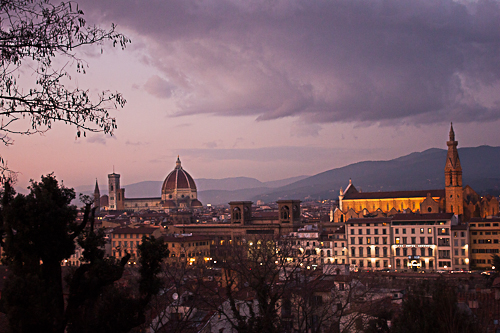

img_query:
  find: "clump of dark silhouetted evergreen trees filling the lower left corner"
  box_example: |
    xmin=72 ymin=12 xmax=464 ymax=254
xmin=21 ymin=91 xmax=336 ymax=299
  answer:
xmin=0 ymin=175 xmax=168 ymax=333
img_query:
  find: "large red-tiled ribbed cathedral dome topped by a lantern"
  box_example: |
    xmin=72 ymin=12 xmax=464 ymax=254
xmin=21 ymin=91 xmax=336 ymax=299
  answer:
xmin=161 ymin=156 xmax=202 ymax=209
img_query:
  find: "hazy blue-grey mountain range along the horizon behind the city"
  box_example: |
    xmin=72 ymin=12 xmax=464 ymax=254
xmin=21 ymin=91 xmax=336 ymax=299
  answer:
xmin=71 ymin=146 xmax=500 ymax=205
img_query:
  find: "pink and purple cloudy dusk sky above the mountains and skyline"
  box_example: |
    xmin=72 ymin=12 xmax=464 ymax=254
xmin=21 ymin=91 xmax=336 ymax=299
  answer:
xmin=0 ymin=0 xmax=500 ymax=192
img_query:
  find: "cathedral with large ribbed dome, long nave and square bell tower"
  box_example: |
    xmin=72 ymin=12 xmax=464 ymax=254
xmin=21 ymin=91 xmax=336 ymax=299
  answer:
xmin=105 ymin=156 xmax=202 ymax=211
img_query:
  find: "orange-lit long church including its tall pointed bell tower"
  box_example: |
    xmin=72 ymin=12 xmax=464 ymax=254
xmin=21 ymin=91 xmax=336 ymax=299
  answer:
xmin=330 ymin=124 xmax=498 ymax=222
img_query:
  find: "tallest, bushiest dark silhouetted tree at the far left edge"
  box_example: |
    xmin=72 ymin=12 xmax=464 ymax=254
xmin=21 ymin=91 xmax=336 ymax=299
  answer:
xmin=0 ymin=175 xmax=84 ymax=332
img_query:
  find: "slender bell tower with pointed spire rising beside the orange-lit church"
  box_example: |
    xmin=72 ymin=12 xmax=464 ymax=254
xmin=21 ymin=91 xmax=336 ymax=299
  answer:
xmin=444 ymin=123 xmax=464 ymax=215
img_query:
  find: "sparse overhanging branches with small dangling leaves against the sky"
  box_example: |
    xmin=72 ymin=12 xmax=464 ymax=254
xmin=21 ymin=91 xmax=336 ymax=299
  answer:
xmin=0 ymin=0 xmax=130 ymax=179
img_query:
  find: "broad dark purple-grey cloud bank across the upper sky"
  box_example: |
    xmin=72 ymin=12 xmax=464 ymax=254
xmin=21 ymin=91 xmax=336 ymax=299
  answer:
xmin=83 ymin=0 xmax=500 ymax=124
